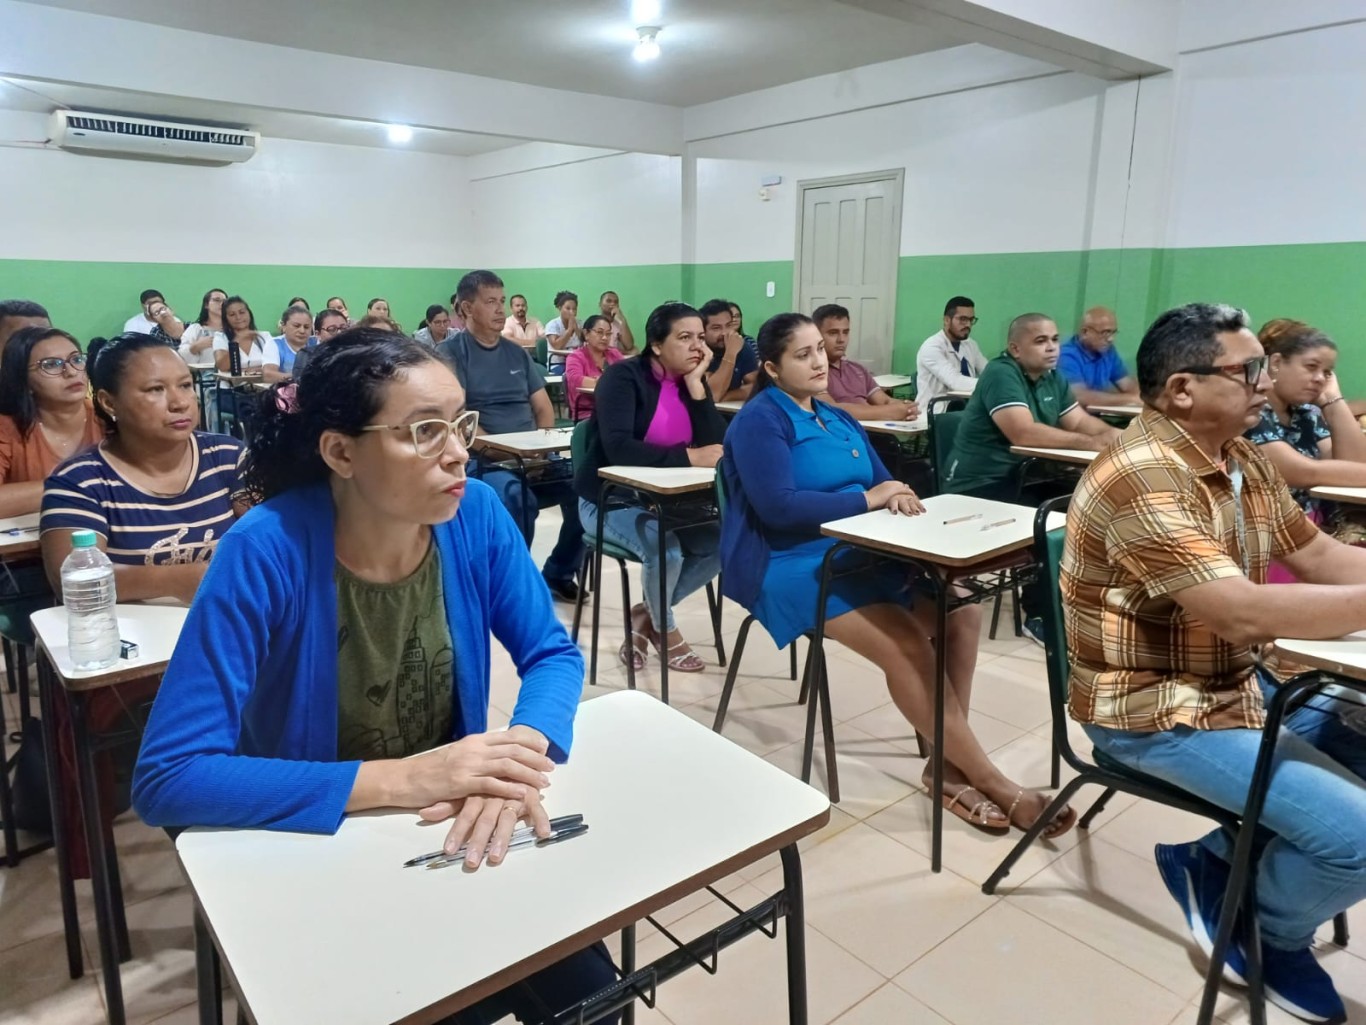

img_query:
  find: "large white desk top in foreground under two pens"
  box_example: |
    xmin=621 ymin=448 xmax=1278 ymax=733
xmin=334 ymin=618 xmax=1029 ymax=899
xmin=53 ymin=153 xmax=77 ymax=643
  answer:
xmin=176 ymin=692 xmax=829 ymax=1025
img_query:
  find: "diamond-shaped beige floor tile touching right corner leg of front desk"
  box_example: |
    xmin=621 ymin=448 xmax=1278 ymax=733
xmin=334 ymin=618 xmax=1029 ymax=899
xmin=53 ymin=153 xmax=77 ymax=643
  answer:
xmin=757 ymin=823 xmax=997 ymax=979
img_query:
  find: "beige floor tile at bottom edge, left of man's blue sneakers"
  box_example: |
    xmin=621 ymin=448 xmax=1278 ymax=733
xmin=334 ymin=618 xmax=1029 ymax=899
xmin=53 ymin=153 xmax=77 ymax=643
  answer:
xmin=895 ymin=902 xmax=1184 ymax=1025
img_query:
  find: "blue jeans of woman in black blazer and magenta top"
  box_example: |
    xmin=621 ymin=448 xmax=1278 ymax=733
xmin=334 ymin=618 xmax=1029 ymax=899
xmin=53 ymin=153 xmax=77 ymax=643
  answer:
xmin=579 ymin=499 xmax=721 ymax=631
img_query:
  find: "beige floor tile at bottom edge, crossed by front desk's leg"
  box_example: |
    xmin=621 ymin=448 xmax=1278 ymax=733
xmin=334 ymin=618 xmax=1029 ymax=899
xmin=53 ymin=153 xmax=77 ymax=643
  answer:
xmin=642 ymin=912 xmax=884 ymax=1025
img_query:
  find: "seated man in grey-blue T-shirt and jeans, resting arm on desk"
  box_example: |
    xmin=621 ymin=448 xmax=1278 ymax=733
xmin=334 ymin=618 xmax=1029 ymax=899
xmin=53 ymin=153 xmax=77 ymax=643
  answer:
xmin=436 ymin=271 xmax=583 ymax=601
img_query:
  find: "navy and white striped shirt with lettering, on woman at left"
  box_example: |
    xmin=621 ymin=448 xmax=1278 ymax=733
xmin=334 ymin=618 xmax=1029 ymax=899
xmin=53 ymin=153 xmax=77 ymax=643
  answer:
xmin=38 ymin=431 xmax=245 ymax=566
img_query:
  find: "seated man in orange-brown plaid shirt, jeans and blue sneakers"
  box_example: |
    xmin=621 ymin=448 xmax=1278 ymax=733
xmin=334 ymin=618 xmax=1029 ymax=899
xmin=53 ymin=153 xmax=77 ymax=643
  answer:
xmin=1061 ymin=303 xmax=1366 ymax=1022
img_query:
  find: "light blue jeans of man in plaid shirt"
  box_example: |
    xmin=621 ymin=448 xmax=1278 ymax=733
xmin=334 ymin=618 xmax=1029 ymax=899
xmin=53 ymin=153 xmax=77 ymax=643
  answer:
xmin=1083 ymin=674 xmax=1366 ymax=950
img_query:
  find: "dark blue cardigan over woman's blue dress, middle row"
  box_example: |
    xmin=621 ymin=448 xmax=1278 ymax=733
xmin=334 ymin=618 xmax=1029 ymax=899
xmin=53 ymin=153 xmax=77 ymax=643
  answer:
xmin=721 ymin=387 xmax=892 ymax=608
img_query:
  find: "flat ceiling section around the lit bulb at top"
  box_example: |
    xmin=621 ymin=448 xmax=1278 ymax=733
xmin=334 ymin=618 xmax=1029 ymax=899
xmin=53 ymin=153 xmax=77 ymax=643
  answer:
xmin=18 ymin=0 xmax=966 ymax=107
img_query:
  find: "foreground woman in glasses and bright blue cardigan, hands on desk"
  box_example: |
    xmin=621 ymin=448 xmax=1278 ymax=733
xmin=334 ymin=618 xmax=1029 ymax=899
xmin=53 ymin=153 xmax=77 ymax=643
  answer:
xmin=133 ymin=329 xmax=613 ymax=1022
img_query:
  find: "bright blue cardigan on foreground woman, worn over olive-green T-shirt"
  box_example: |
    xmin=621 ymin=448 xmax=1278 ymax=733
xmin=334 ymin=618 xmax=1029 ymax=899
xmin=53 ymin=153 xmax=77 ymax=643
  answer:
xmin=133 ymin=480 xmax=583 ymax=832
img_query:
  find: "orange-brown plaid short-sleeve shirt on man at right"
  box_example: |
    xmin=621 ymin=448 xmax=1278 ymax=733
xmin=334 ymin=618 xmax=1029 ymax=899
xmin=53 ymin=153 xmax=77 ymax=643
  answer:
xmin=1061 ymin=409 xmax=1318 ymax=733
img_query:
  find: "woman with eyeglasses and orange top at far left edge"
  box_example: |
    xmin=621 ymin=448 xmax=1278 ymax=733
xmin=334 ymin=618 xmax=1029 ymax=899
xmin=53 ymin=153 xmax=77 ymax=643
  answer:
xmin=0 ymin=328 xmax=104 ymax=517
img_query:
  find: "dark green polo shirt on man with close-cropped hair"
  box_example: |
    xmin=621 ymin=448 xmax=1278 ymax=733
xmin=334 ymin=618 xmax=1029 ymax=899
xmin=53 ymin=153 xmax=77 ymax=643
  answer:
xmin=944 ymin=353 xmax=1076 ymax=495
